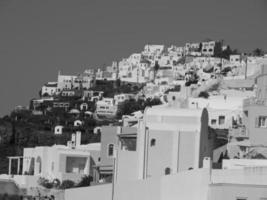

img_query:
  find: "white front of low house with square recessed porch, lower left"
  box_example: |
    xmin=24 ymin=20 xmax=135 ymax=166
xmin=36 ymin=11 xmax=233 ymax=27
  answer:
xmin=23 ymin=145 xmax=94 ymax=181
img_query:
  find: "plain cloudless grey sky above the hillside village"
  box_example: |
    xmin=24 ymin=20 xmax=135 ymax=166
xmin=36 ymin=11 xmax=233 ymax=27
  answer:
xmin=0 ymin=0 xmax=267 ymax=116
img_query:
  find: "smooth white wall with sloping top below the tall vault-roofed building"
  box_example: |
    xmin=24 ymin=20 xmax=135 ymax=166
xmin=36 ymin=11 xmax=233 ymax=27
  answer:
xmin=115 ymin=169 xmax=209 ymax=200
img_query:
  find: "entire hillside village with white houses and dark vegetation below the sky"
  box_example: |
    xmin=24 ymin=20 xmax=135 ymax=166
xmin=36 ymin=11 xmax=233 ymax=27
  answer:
xmin=0 ymin=40 xmax=267 ymax=200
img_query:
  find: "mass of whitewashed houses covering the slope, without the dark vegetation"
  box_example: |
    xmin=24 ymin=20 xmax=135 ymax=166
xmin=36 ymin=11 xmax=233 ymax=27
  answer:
xmin=2 ymin=41 xmax=267 ymax=200
